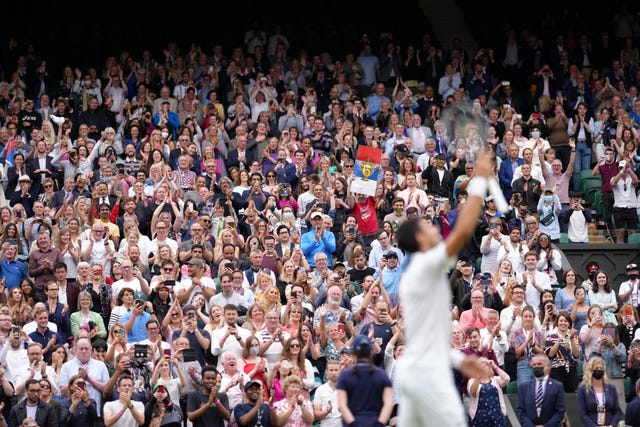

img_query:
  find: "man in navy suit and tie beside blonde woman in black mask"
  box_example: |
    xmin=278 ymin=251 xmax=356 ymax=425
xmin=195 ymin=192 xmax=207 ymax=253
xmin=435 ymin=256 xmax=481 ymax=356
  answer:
xmin=516 ymin=354 xmax=565 ymax=427
